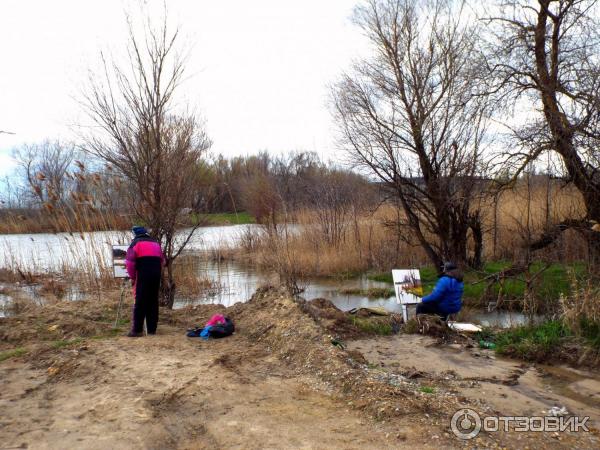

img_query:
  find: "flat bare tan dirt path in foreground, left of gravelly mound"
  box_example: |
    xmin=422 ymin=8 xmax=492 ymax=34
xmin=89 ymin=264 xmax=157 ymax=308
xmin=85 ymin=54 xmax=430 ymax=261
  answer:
xmin=0 ymin=327 xmax=422 ymax=449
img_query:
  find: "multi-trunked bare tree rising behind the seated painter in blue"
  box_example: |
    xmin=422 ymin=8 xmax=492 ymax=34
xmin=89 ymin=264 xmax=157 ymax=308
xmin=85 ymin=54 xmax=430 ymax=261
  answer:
xmin=333 ymin=0 xmax=486 ymax=267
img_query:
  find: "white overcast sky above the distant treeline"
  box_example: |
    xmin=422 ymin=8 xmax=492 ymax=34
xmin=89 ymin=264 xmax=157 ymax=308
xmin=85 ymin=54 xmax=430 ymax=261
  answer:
xmin=0 ymin=0 xmax=366 ymax=175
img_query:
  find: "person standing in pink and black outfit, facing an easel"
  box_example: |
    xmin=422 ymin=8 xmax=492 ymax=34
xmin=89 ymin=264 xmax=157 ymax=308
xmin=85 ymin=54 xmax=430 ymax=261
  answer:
xmin=125 ymin=226 xmax=165 ymax=337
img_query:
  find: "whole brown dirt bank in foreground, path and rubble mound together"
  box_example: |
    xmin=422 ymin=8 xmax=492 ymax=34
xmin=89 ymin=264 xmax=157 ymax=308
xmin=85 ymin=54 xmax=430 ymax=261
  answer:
xmin=0 ymin=289 xmax=598 ymax=449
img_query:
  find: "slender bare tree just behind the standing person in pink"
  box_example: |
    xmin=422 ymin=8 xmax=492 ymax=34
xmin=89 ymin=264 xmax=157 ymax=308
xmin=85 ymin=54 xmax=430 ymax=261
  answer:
xmin=83 ymin=13 xmax=210 ymax=307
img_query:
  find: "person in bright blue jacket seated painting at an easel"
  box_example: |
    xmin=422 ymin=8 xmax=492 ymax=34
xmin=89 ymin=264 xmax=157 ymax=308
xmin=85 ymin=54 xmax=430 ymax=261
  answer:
xmin=417 ymin=262 xmax=464 ymax=320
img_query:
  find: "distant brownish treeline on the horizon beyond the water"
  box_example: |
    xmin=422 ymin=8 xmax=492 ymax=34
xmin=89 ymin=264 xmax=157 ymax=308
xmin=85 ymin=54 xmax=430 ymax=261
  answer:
xmin=0 ymin=141 xmax=381 ymax=232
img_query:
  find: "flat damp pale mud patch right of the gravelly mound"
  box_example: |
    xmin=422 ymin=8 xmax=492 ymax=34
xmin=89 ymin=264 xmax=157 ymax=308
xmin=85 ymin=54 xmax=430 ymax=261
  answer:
xmin=346 ymin=335 xmax=600 ymax=426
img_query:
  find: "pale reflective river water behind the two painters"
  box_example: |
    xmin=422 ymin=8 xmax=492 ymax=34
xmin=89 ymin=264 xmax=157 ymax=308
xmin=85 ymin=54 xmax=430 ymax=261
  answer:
xmin=0 ymin=224 xmax=526 ymax=327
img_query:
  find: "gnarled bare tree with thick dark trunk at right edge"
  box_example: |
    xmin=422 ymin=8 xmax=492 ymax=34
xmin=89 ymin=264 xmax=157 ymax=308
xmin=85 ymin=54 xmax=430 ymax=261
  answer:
xmin=487 ymin=0 xmax=600 ymax=262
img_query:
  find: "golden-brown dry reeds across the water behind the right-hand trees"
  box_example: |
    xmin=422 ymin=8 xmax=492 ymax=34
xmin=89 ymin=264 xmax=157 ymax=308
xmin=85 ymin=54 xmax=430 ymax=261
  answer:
xmin=229 ymin=177 xmax=587 ymax=276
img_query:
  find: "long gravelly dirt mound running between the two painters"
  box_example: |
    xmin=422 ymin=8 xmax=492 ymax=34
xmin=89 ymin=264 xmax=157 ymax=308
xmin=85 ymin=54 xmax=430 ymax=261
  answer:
xmin=166 ymin=286 xmax=442 ymax=418
